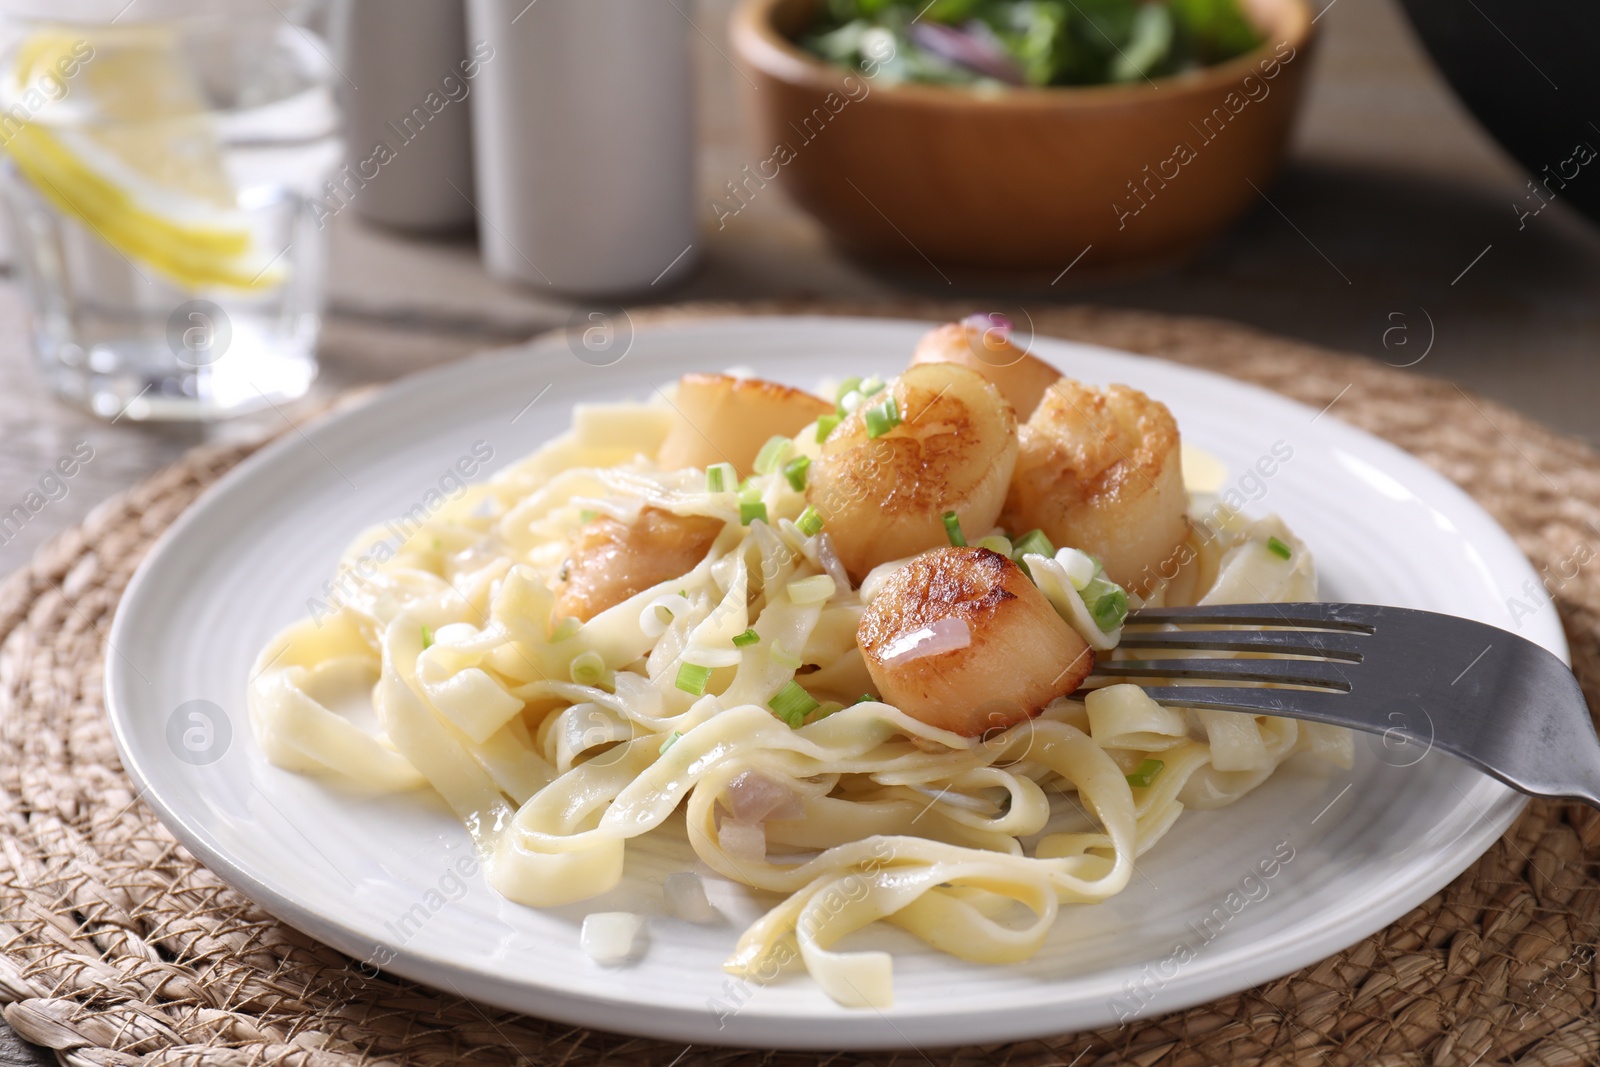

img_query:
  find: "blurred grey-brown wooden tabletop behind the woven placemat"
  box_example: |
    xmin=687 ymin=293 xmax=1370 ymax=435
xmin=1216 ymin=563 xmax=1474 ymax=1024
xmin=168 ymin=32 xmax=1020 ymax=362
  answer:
xmin=0 ymin=0 xmax=1600 ymax=571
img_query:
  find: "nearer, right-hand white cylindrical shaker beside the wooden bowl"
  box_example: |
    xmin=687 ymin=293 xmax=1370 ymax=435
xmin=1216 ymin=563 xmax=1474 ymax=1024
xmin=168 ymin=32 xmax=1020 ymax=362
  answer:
xmin=467 ymin=0 xmax=698 ymax=296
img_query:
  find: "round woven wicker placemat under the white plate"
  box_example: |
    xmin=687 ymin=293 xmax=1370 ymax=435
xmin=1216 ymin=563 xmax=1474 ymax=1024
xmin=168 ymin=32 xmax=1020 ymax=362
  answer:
xmin=0 ymin=304 xmax=1600 ymax=1067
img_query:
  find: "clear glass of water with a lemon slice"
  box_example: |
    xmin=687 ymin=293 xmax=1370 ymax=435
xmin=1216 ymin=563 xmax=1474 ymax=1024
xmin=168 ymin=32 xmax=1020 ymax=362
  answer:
xmin=0 ymin=0 xmax=341 ymax=419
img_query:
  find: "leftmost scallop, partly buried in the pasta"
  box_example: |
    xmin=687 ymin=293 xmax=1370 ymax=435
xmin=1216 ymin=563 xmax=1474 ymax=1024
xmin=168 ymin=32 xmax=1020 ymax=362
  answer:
xmin=550 ymin=507 xmax=723 ymax=625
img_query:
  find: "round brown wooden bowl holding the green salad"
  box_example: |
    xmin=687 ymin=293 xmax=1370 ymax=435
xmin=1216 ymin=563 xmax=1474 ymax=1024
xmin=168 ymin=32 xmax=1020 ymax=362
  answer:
xmin=732 ymin=0 xmax=1315 ymax=282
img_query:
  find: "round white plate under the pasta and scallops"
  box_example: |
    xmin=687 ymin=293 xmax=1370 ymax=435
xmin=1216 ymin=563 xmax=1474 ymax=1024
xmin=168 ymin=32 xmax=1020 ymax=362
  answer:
xmin=106 ymin=318 xmax=1566 ymax=1048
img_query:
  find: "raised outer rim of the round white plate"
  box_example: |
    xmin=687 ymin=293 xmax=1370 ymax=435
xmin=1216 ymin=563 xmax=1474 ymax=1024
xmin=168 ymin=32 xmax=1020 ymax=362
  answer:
xmin=102 ymin=314 xmax=1548 ymax=1049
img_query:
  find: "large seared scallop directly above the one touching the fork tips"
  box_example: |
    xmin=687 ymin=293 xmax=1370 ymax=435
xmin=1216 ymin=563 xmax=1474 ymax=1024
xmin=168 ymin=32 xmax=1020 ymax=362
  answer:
xmin=806 ymin=363 xmax=1016 ymax=582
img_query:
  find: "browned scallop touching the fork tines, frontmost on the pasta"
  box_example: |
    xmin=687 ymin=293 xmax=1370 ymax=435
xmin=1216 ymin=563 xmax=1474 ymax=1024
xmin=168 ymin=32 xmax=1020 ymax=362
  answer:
xmin=856 ymin=549 xmax=1094 ymax=737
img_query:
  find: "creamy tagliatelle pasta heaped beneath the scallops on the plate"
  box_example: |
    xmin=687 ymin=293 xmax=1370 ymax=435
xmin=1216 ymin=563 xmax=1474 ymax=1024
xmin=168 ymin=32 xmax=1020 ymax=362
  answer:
xmin=250 ymin=343 xmax=1350 ymax=1006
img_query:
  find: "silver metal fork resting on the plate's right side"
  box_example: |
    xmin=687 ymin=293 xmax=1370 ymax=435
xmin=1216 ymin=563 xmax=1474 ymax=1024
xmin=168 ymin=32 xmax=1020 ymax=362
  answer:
xmin=1093 ymin=603 xmax=1600 ymax=808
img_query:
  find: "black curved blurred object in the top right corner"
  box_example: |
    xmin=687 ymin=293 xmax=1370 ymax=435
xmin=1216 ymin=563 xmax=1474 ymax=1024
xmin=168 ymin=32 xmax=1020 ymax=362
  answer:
xmin=1402 ymin=0 xmax=1600 ymax=222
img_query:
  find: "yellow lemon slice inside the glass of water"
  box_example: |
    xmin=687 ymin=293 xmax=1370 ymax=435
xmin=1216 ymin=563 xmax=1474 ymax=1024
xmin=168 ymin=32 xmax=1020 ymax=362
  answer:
xmin=5 ymin=27 xmax=283 ymax=290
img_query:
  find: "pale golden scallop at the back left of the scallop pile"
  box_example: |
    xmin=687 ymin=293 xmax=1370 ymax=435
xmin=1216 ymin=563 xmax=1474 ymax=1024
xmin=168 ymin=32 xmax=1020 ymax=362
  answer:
xmin=656 ymin=374 xmax=834 ymax=478
